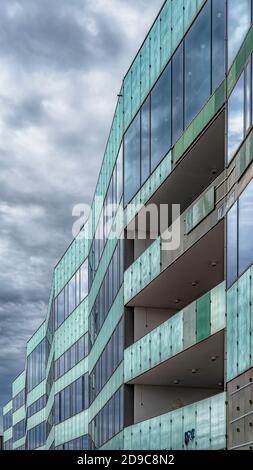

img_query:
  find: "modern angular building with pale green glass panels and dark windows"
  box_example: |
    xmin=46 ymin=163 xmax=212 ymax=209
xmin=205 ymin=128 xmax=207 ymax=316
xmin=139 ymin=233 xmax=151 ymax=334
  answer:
xmin=3 ymin=0 xmax=253 ymax=450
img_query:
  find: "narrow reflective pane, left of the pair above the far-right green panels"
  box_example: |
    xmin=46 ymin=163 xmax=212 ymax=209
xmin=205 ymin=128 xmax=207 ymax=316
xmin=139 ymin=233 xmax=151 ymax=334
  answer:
xmin=227 ymin=203 xmax=237 ymax=287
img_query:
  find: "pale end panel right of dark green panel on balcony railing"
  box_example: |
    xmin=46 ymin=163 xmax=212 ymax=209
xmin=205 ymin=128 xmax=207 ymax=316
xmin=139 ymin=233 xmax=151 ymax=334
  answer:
xmin=211 ymin=282 xmax=226 ymax=335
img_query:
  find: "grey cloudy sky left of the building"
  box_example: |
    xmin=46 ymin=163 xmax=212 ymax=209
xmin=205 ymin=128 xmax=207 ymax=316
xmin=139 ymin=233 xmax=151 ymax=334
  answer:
xmin=0 ymin=0 xmax=163 ymax=431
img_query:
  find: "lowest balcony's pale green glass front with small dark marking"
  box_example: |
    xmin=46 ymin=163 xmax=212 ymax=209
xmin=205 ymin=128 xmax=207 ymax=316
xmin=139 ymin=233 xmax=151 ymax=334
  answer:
xmin=103 ymin=393 xmax=226 ymax=450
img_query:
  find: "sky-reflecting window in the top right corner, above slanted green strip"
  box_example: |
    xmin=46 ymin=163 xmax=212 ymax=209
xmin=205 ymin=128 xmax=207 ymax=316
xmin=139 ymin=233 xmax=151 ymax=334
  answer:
xmin=227 ymin=0 xmax=251 ymax=67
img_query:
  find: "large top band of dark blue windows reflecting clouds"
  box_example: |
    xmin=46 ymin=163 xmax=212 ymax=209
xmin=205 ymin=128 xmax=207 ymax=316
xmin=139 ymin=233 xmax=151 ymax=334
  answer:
xmin=124 ymin=0 xmax=226 ymax=206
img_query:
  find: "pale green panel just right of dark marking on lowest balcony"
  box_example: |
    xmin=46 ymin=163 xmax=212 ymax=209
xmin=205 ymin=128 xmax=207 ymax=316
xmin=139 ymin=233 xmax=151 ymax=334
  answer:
xmin=195 ymin=400 xmax=211 ymax=450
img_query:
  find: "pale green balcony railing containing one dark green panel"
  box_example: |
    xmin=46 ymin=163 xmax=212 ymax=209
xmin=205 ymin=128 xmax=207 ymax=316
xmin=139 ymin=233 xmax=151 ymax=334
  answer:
xmin=124 ymin=282 xmax=226 ymax=382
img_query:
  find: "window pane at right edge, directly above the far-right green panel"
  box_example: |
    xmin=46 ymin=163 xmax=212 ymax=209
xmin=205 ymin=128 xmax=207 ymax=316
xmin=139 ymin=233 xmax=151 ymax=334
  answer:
xmin=239 ymin=182 xmax=253 ymax=274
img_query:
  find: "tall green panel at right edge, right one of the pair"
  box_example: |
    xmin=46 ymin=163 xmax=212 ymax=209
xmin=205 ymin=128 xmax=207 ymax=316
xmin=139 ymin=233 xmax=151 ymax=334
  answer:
xmin=238 ymin=270 xmax=250 ymax=373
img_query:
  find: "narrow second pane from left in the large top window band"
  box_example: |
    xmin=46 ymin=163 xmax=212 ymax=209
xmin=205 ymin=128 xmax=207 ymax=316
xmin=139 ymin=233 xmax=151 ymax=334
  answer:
xmin=141 ymin=97 xmax=150 ymax=184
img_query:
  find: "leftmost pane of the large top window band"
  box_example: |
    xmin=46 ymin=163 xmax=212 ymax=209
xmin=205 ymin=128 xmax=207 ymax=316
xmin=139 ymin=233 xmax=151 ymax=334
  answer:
xmin=124 ymin=113 xmax=140 ymax=205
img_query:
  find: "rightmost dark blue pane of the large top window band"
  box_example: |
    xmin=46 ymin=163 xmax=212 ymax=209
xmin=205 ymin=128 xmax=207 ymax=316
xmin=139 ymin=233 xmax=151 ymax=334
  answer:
xmin=212 ymin=0 xmax=225 ymax=91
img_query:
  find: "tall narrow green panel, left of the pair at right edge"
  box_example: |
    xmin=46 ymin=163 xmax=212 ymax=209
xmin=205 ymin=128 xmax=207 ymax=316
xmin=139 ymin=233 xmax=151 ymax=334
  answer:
xmin=227 ymin=284 xmax=238 ymax=381
